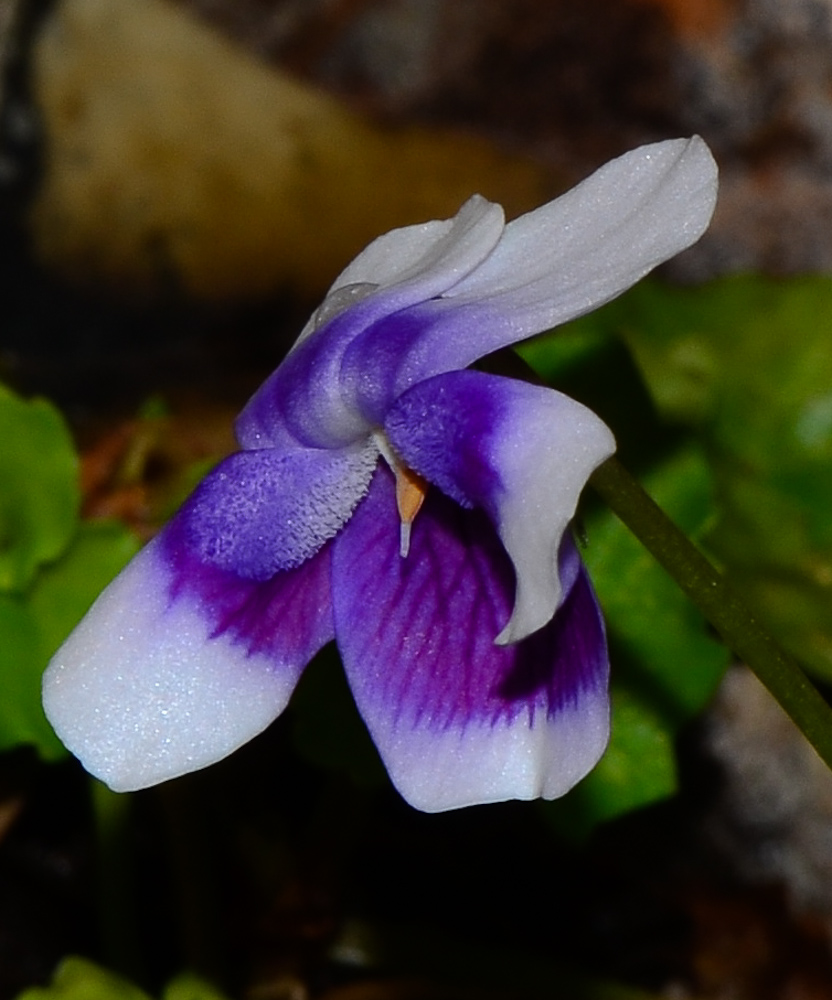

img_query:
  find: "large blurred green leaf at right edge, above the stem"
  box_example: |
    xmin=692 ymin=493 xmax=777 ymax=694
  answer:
xmin=602 ymin=276 xmax=832 ymax=682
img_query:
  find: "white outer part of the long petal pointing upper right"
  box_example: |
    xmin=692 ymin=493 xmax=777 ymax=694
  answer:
xmin=446 ymin=136 xmax=717 ymax=324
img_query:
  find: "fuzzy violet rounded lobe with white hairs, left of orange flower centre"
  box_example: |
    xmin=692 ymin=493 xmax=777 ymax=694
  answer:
xmin=182 ymin=440 xmax=378 ymax=580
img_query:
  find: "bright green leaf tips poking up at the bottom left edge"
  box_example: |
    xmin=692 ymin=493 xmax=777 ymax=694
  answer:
xmin=17 ymin=955 xmax=229 ymax=1000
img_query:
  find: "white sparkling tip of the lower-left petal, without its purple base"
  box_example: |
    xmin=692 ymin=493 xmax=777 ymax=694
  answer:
xmin=43 ymin=542 xmax=298 ymax=792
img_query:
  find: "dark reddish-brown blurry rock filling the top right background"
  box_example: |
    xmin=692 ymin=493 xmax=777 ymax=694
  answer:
xmin=179 ymin=0 xmax=832 ymax=280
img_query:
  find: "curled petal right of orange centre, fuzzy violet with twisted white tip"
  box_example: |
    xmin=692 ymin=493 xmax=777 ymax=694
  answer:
xmin=385 ymin=370 xmax=615 ymax=643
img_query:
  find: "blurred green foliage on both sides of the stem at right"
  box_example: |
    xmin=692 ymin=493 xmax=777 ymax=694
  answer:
xmin=520 ymin=276 xmax=832 ymax=831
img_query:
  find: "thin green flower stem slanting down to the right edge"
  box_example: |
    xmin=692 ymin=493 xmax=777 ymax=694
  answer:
xmin=590 ymin=458 xmax=832 ymax=768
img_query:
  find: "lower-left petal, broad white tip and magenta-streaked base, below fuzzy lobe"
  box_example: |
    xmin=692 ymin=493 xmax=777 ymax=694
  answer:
xmin=38 ymin=522 xmax=333 ymax=792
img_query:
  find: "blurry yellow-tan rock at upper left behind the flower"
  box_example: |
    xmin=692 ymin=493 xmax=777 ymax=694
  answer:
xmin=31 ymin=0 xmax=552 ymax=299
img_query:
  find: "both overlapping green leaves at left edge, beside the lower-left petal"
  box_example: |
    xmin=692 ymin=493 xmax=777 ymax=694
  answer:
xmin=0 ymin=386 xmax=138 ymax=759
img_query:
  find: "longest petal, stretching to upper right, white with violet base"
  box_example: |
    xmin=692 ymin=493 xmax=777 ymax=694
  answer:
xmin=343 ymin=136 xmax=717 ymax=420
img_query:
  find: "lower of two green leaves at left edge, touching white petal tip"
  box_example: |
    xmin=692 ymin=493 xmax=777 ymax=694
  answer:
xmin=0 ymin=522 xmax=138 ymax=760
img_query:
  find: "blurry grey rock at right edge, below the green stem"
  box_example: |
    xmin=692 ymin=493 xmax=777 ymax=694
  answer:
xmin=705 ymin=667 xmax=832 ymax=939
